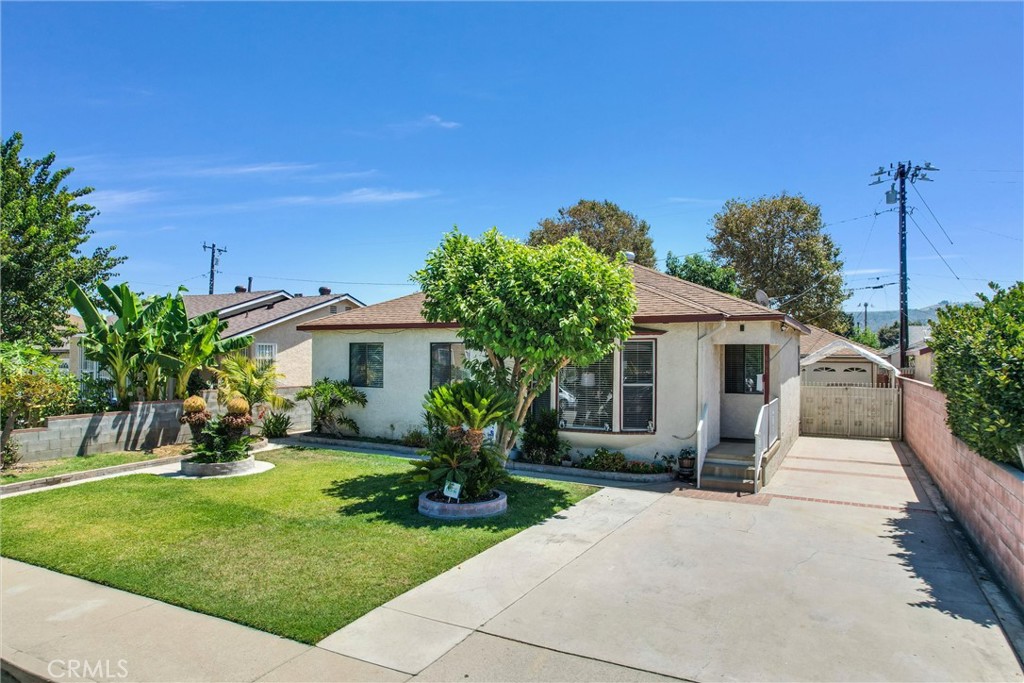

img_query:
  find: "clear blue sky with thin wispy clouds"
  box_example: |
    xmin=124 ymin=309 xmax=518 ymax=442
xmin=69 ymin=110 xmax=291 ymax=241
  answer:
xmin=0 ymin=2 xmax=1024 ymax=309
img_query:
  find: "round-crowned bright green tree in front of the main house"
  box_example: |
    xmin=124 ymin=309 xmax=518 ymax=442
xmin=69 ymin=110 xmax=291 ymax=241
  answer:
xmin=413 ymin=229 xmax=637 ymax=453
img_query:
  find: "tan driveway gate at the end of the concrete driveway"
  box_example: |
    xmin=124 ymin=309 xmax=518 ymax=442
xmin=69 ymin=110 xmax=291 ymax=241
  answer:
xmin=800 ymin=384 xmax=900 ymax=438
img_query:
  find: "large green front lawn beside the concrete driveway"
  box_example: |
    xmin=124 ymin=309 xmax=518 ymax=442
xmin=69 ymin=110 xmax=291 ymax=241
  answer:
xmin=2 ymin=449 xmax=595 ymax=643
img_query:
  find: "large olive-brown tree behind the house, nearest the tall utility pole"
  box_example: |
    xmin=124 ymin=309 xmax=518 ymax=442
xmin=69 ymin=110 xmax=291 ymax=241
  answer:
xmin=709 ymin=193 xmax=850 ymax=334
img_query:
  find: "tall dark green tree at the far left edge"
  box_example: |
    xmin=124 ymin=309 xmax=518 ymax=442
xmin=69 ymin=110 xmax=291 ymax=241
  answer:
xmin=0 ymin=133 xmax=125 ymax=346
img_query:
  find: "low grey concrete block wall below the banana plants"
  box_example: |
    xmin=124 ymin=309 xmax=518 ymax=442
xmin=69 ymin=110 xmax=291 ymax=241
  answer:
xmin=11 ymin=387 xmax=310 ymax=463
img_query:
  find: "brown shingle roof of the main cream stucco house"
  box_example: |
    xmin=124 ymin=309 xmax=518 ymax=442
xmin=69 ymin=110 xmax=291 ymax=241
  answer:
xmin=298 ymin=264 xmax=807 ymax=333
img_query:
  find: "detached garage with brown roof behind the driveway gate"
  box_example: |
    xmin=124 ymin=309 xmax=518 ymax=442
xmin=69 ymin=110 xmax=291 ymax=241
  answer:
xmin=800 ymin=325 xmax=898 ymax=387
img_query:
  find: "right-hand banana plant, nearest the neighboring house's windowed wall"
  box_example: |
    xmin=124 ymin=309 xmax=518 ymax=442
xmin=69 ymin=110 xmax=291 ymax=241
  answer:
xmin=164 ymin=295 xmax=253 ymax=398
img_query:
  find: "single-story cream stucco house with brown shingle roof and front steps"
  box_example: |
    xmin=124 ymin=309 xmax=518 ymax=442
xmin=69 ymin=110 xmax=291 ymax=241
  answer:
xmin=298 ymin=263 xmax=809 ymax=491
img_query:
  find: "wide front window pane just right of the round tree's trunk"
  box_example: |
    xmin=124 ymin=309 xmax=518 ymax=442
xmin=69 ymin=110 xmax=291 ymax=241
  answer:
xmin=558 ymin=353 xmax=614 ymax=431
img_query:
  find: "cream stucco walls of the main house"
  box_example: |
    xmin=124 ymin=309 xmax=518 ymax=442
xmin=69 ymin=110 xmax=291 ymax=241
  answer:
xmin=312 ymin=322 xmax=800 ymax=458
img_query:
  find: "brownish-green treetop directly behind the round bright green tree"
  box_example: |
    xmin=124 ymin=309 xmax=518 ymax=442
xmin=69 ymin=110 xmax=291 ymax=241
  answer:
xmin=526 ymin=200 xmax=654 ymax=268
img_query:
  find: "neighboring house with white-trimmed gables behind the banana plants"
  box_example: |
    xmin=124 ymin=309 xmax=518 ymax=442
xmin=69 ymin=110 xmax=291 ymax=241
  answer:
xmin=183 ymin=287 xmax=364 ymax=386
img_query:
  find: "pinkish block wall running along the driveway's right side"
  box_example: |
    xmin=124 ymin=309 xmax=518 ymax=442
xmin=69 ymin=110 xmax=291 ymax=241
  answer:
xmin=902 ymin=379 xmax=1024 ymax=606
